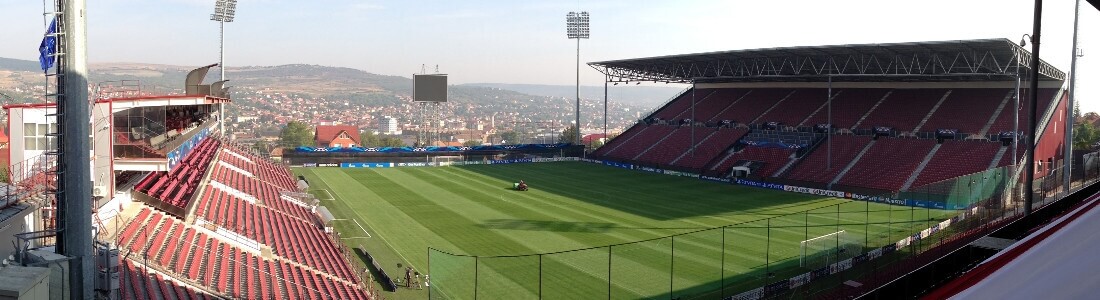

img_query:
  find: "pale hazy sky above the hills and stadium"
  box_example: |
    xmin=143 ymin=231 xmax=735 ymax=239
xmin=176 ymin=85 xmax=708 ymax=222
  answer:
xmin=0 ymin=0 xmax=1100 ymax=111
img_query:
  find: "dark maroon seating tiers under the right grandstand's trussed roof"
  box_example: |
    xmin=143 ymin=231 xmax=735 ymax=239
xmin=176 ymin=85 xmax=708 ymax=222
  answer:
xmin=594 ymin=82 xmax=1058 ymax=191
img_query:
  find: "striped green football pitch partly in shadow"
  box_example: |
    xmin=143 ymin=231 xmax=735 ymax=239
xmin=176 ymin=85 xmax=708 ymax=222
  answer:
xmin=294 ymin=163 xmax=952 ymax=299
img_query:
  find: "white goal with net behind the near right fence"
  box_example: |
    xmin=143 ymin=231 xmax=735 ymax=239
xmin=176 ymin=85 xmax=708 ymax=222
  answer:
xmin=799 ymin=231 xmax=860 ymax=269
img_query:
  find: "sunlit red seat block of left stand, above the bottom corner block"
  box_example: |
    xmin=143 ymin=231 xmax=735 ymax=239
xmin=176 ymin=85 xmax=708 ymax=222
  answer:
xmin=119 ymin=208 xmax=370 ymax=299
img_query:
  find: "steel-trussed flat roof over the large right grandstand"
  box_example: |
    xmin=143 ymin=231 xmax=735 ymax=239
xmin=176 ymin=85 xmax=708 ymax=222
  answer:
xmin=589 ymin=38 xmax=1066 ymax=82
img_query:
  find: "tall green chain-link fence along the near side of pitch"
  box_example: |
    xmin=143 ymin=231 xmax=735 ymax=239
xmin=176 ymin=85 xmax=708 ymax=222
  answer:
xmin=428 ymin=149 xmax=1100 ymax=299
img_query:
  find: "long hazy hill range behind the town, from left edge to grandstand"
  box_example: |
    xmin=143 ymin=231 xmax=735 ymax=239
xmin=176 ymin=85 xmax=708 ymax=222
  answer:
xmin=0 ymin=58 xmax=651 ymax=121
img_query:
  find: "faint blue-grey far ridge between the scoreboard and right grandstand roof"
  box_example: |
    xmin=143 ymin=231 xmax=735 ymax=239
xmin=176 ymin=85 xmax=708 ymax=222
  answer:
xmin=462 ymin=84 xmax=684 ymax=108
